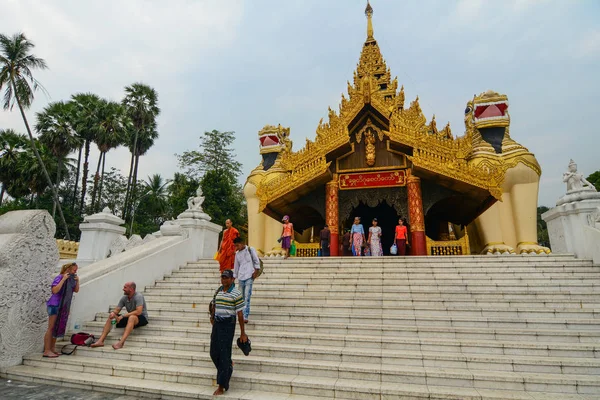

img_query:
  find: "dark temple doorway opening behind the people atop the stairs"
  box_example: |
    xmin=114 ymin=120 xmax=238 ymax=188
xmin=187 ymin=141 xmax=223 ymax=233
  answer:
xmin=342 ymin=200 xmax=398 ymax=256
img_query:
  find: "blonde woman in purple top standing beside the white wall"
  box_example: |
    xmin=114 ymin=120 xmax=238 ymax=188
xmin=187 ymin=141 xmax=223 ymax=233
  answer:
xmin=44 ymin=263 xmax=79 ymax=358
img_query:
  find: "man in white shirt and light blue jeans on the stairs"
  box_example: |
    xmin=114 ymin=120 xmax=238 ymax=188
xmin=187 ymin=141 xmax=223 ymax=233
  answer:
xmin=233 ymin=237 xmax=260 ymax=324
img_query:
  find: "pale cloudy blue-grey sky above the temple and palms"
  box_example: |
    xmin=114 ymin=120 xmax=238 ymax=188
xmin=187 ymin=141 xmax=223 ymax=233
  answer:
xmin=0 ymin=0 xmax=600 ymax=206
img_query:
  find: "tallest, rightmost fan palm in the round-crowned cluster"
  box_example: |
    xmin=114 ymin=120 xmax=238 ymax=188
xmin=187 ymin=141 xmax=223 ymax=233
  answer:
xmin=122 ymin=83 xmax=160 ymax=219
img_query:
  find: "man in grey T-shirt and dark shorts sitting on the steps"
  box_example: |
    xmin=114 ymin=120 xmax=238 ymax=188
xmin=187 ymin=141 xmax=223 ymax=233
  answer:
xmin=91 ymin=282 xmax=148 ymax=350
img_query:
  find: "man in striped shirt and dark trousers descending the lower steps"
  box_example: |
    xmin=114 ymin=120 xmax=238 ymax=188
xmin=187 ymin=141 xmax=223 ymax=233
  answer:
xmin=210 ymin=269 xmax=248 ymax=396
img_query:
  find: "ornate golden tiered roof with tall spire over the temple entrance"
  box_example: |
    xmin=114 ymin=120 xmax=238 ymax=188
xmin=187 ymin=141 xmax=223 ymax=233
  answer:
xmin=257 ymin=3 xmax=503 ymax=211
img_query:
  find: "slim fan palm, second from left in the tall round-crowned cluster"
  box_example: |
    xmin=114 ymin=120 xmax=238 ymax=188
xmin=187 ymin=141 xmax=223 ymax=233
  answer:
xmin=72 ymin=93 xmax=102 ymax=212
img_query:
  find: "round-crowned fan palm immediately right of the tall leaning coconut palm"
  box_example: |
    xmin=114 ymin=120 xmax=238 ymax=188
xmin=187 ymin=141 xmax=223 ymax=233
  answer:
xmin=35 ymin=101 xmax=83 ymax=217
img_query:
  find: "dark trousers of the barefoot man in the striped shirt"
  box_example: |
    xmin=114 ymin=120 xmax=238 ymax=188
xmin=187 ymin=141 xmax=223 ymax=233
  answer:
xmin=210 ymin=317 xmax=236 ymax=390
